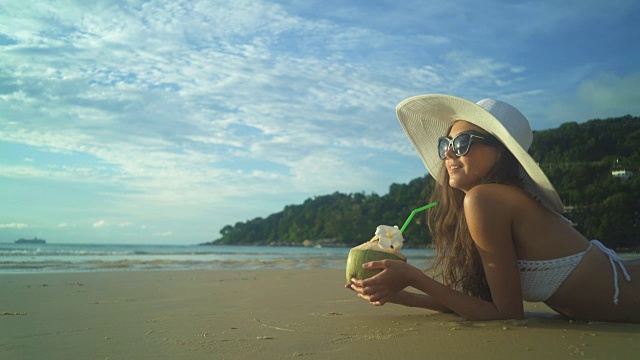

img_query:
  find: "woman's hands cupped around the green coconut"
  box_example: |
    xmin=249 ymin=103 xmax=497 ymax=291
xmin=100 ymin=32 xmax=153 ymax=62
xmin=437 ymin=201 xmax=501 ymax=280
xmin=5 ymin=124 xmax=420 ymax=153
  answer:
xmin=346 ymin=260 xmax=420 ymax=306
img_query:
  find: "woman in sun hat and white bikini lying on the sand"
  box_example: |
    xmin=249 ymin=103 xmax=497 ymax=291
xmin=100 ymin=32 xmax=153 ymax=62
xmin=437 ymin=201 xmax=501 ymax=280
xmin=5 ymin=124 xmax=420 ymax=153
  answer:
xmin=346 ymin=95 xmax=640 ymax=322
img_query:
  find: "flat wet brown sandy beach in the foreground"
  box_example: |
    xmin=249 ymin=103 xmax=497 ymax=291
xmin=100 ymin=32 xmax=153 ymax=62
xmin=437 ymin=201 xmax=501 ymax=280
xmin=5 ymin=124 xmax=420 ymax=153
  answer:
xmin=0 ymin=269 xmax=640 ymax=359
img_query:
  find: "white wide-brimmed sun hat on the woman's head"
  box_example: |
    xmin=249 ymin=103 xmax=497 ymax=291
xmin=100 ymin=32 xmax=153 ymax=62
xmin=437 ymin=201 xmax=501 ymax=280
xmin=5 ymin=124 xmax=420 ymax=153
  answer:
xmin=396 ymin=94 xmax=564 ymax=214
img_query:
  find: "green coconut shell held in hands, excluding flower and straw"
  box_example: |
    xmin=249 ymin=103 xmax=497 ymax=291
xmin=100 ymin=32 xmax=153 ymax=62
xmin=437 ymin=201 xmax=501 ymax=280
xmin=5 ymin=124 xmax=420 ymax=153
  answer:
xmin=346 ymin=236 xmax=407 ymax=284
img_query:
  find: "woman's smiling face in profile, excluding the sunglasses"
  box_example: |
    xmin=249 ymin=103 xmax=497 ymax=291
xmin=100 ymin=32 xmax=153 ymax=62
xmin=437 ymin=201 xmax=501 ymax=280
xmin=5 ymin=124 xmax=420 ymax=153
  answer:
xmin=444 ymin=120 xmax=500 ymax=193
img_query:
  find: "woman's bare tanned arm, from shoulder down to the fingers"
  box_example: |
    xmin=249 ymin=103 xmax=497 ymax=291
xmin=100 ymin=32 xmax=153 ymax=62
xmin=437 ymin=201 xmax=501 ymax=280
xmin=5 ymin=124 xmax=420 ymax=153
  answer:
xmin=354 ymin=185 xmax=524 ymax=320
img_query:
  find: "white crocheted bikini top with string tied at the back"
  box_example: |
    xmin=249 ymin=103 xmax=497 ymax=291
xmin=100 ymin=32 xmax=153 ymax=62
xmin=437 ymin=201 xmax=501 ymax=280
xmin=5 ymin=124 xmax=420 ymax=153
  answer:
xmin=518 ymin=240 xmax=631 ymax=305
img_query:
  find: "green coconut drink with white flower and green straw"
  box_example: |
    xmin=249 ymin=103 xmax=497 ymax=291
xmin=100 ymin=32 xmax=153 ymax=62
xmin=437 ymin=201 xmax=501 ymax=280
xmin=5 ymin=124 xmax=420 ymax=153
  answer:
xmin=346 ymin=203 xmax=437 ymax=284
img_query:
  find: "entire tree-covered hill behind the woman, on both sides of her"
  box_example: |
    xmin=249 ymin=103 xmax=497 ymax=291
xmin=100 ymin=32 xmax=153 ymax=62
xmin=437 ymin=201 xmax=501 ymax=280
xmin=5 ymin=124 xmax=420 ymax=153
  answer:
xmin=207 ymin=115 xmax=640 ymax=248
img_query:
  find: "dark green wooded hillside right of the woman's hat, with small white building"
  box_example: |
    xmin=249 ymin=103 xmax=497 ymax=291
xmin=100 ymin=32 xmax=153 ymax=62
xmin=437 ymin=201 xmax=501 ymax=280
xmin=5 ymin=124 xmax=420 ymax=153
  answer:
xmin=530 ymin=115 xmax=640 ymax=248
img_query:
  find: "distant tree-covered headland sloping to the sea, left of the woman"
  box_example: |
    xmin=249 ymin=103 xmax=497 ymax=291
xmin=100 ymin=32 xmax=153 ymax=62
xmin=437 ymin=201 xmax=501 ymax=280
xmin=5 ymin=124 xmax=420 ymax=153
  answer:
xmin=215 ymin=175 xmax=433 ymax=246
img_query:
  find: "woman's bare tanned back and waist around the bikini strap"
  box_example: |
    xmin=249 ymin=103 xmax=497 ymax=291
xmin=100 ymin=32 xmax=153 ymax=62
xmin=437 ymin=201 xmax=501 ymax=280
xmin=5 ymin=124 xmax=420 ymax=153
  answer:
xmin=500 ymin=185 xmax=640 ymax=322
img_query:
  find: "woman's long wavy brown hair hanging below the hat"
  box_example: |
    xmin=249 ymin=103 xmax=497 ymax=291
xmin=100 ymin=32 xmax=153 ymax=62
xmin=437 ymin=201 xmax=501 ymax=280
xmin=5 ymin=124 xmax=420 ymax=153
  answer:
xmin=427 ymin=126 xmax=522 ymax=301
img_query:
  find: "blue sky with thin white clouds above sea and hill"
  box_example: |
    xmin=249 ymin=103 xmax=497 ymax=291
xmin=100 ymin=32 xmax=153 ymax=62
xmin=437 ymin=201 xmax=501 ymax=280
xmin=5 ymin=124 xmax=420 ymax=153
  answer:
xmin=0 ymin=0 xmax=640 ymax=244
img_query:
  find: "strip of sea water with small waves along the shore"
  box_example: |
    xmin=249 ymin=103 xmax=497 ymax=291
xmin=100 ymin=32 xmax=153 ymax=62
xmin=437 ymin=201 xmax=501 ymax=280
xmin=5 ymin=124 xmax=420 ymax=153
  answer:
xmin=0 ymin=243 xmax=434 ymax=274
